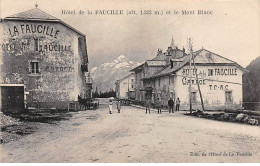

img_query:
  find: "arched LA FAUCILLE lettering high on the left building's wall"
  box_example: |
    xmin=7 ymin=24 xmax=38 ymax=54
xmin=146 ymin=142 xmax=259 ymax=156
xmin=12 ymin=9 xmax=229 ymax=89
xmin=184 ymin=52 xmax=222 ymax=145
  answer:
xmin=8 ymin=24 xmax=60 ymax=39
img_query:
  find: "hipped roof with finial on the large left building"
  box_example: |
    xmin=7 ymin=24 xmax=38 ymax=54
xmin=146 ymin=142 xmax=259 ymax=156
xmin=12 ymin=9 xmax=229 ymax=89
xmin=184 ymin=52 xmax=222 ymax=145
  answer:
xmin=4 ymin=7 xmax=85 ymax=36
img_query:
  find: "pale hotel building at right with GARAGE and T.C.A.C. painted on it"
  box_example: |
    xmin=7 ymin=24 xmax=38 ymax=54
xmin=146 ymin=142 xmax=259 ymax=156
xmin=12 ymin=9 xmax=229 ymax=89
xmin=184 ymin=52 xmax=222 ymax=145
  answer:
xmin=131 ymin=37 xmax=246 ymax=110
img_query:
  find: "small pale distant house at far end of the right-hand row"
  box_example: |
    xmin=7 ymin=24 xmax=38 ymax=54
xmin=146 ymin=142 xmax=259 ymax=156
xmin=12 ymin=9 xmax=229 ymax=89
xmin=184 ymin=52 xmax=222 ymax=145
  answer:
xmin=116 ymin=73 xmax=135 ymax=99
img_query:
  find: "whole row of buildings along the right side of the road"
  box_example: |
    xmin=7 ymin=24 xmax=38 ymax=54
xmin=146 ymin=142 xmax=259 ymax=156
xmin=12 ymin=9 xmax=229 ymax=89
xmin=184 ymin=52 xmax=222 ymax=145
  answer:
xmin=116 ymin=39 xmax=246 ymax=110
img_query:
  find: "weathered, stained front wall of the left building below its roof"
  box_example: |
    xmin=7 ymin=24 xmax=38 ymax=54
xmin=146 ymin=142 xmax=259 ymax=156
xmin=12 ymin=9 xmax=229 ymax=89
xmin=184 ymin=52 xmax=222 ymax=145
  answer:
xmin=0 ymin=21 xmax=86 ymax=109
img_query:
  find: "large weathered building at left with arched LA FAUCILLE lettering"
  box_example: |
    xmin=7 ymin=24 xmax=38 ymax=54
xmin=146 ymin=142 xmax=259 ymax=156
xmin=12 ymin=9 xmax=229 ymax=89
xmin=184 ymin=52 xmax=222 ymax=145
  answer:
xmin=0 ymin=7 xmax=91 ymax=110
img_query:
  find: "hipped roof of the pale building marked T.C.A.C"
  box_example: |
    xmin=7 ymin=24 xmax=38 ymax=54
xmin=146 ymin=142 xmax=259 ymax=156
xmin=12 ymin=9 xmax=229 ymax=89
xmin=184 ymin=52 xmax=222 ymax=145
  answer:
xmin=145 ymin=49 xmax=246 ymax=79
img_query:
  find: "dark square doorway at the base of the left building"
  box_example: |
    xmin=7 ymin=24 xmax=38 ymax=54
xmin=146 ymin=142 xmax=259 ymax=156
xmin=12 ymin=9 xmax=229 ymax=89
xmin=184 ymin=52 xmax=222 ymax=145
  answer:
xmin=1 ymin=86 xmax=24 ymax=112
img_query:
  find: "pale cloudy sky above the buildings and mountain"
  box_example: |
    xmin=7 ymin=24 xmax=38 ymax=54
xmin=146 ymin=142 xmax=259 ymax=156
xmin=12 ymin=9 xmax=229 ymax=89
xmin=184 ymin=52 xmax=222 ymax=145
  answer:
xmin=0 ymin=0 xmax=260 ymax=68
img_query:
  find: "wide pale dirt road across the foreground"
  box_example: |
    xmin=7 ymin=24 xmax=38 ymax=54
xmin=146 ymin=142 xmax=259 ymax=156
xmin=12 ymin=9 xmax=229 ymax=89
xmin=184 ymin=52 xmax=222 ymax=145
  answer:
xmin=0 ymin=105 xmax=260 ymax=162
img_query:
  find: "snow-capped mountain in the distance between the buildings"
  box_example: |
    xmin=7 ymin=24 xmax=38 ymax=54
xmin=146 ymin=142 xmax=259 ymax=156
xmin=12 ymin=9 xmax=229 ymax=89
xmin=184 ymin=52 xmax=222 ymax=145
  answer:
xmin=90 ymin=55 xmax=140 ymax=92
